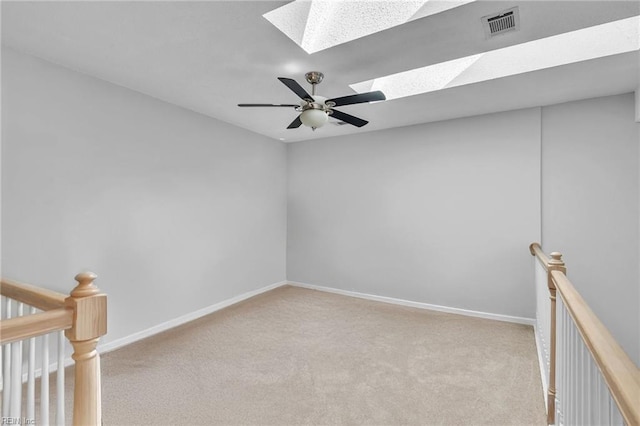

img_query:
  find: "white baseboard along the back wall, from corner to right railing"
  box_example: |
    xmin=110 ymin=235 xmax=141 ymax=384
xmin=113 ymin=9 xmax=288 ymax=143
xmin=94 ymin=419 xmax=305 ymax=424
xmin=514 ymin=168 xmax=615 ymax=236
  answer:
xmin=288 ymin=281 xmax=536 ymax=325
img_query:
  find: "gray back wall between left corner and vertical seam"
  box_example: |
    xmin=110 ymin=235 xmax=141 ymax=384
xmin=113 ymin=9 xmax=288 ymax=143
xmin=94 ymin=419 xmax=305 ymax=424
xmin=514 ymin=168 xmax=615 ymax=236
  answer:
xmin=287 ymin=108 xmax=540 ymax=318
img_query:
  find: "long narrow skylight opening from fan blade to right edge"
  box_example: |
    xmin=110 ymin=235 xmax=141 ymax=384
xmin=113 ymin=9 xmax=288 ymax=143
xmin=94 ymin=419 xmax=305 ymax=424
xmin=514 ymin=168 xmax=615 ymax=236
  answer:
xmin=351 ymin=16 xmax=640 ymax=100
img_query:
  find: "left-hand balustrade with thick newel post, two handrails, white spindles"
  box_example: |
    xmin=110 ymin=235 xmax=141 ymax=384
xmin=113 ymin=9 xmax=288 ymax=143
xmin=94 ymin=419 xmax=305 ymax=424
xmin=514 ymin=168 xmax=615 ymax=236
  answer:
xmin=0 ymin=272 xmax=107 ymax=426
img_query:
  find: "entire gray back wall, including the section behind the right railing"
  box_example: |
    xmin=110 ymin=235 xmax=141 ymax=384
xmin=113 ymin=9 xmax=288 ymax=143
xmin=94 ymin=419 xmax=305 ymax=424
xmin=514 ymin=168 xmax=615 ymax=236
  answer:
xmin=287 ymin=94 xmax=640 ymax=363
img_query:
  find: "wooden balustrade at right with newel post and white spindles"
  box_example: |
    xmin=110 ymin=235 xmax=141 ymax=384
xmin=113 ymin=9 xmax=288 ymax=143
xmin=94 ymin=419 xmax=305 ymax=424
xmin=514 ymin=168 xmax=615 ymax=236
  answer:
xmin=529 ymin=243 xmax=640 ymax=425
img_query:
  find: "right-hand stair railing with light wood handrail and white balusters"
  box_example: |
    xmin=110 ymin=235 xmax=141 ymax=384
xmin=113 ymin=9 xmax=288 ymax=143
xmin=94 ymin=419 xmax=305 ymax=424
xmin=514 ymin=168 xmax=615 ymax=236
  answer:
xmin=529 ymin=243 xmax=640 ymax=426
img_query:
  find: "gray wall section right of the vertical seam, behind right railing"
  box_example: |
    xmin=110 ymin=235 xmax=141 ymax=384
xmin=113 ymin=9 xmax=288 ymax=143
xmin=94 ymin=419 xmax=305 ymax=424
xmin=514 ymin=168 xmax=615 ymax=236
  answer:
xmin=542 ymin=94 xmax=640 ymax=364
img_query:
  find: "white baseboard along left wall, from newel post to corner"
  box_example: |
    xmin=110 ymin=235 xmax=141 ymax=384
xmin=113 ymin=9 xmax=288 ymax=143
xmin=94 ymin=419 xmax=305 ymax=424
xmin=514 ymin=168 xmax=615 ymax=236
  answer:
xmin=98 ymin=281 xmax=288 ymax=353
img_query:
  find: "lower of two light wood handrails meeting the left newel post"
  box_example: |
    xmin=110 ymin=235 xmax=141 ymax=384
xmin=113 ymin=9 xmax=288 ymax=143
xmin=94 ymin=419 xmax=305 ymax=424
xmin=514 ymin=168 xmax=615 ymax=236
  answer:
xmin=0 ymin=308 xmax=73 ymax=345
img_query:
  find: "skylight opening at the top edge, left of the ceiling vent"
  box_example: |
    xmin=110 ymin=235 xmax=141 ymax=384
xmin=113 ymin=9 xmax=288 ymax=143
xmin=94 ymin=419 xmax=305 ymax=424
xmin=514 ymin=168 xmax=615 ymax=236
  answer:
xmin=263 ymin=0 xmax=475 ymax=53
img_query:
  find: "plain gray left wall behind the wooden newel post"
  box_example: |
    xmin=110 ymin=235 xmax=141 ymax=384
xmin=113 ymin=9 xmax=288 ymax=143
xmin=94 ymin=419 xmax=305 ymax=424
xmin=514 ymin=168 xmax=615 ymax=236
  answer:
xmin=2 ymin=49 xmax=286 ymax=348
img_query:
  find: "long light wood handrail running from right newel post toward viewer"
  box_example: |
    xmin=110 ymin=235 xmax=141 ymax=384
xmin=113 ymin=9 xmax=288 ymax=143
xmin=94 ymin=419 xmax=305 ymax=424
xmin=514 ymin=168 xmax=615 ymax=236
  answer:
xmin=552 ymin=270 xmax=640 ymax=425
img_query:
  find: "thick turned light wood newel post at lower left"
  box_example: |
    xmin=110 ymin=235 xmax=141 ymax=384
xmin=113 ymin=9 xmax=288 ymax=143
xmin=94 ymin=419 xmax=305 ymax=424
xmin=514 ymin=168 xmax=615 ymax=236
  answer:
xmin=65 ymin=272 xmax=107 ymax=426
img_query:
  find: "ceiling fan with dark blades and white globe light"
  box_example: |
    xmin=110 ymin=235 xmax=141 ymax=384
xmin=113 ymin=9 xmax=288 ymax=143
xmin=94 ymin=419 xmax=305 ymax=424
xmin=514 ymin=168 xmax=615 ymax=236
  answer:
xmin=238 ymin=71 xmax=387 ymax=130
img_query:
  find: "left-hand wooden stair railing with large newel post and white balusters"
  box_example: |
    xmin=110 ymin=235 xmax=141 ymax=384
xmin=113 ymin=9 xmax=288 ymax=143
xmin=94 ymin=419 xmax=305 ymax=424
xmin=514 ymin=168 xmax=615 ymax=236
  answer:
xmin=0 ymin=272 xmax=107 ymax=426
